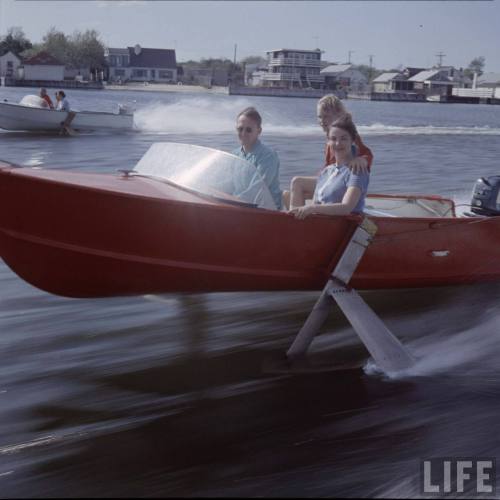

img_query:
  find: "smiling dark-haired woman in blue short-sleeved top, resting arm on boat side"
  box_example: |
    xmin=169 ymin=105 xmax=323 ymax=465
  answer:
xmin=290 ymin=116 xmax=370 ymax=219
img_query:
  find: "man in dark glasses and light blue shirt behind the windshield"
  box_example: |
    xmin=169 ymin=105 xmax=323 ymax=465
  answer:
xmin=233 ymin=107 xmax=282 ymax=209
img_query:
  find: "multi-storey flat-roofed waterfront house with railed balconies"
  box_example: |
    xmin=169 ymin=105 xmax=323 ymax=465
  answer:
xmin=261 ymin=49 xmax=325 ymax=89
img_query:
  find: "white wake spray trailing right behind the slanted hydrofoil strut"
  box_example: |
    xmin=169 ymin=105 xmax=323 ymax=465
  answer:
xmin=364 ymin=284 xmax=500 ymax=384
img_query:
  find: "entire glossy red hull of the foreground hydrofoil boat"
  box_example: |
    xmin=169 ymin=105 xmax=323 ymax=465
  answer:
xmin=0 ymin=162 xmax=500 ymax=297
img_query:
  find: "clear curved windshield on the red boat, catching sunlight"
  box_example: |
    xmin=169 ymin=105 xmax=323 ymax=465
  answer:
xmin=133 ymin=142 xmax=277 ymax=210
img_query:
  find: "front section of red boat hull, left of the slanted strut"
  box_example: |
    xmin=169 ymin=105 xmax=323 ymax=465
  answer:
xmin=0 ymin=152 xmax=357 ymax=297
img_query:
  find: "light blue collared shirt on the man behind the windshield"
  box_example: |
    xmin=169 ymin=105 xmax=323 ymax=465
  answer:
xmin=233 ymin=139 xmax=281 ymax=209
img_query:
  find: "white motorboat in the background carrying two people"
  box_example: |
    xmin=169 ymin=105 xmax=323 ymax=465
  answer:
xmin=0 ymin=95 xmax=134 ymax=132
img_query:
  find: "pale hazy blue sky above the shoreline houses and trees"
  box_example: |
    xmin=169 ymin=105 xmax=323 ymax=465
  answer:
xmin=0 ymin=0 xmax=500 ymax=72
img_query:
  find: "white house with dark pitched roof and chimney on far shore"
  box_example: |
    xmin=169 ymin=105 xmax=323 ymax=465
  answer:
xmin=104 ymin=45 xmax=177 ymax=83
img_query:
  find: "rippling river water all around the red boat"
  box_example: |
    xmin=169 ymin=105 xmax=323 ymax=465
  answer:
xmin=0 ymin=88 xmax=500 ymax=497
